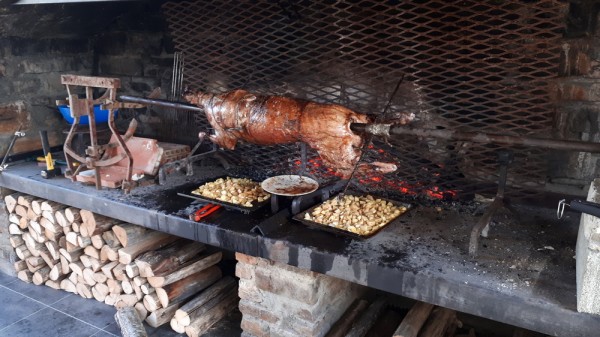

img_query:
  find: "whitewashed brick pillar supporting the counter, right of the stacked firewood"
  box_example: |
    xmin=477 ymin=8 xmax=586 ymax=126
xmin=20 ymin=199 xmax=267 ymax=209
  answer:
xmin=236 ymin=253 xmax=359 ymax=337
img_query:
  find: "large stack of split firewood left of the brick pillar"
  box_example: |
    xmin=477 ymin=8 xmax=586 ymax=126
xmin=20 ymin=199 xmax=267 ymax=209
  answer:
xmin=5 ymin=193 xmax=238 ymax=336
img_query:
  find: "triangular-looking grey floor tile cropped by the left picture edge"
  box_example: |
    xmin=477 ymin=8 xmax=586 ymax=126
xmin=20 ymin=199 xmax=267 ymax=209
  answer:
xmin=0 ymin=286 xmax=45 ymax=330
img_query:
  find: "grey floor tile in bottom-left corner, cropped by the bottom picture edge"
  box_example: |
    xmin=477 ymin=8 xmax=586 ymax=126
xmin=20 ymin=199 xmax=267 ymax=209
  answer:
xmin=0 ymin=308 xmax=99 ymax=337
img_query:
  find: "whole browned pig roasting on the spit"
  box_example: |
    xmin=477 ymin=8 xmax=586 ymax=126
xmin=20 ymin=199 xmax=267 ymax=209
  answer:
xmin=184 ymin=90 xmax=396 ymax=178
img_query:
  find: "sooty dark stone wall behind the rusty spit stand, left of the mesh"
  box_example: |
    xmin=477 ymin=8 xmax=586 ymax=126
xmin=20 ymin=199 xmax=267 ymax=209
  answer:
xmin=0 ymin=1 xmax=173 ymax=155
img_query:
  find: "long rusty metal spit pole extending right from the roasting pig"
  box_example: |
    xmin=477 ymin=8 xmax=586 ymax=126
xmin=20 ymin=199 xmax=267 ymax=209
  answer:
xmin=350 ymin=123 xmax=600 ymax=153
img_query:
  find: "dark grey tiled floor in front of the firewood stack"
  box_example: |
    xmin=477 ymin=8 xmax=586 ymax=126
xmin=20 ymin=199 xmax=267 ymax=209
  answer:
xmin=0 ymin=272 xmax=241 ymax=337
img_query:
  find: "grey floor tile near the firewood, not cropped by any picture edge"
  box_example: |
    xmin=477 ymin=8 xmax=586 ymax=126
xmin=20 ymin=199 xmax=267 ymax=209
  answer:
xmin=51 ymin=294 xmax=117 ymax=332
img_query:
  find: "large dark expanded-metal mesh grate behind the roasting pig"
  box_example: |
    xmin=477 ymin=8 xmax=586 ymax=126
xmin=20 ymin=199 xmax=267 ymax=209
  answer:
xmin=163 ymin=0 xmax=568 ymax=197
